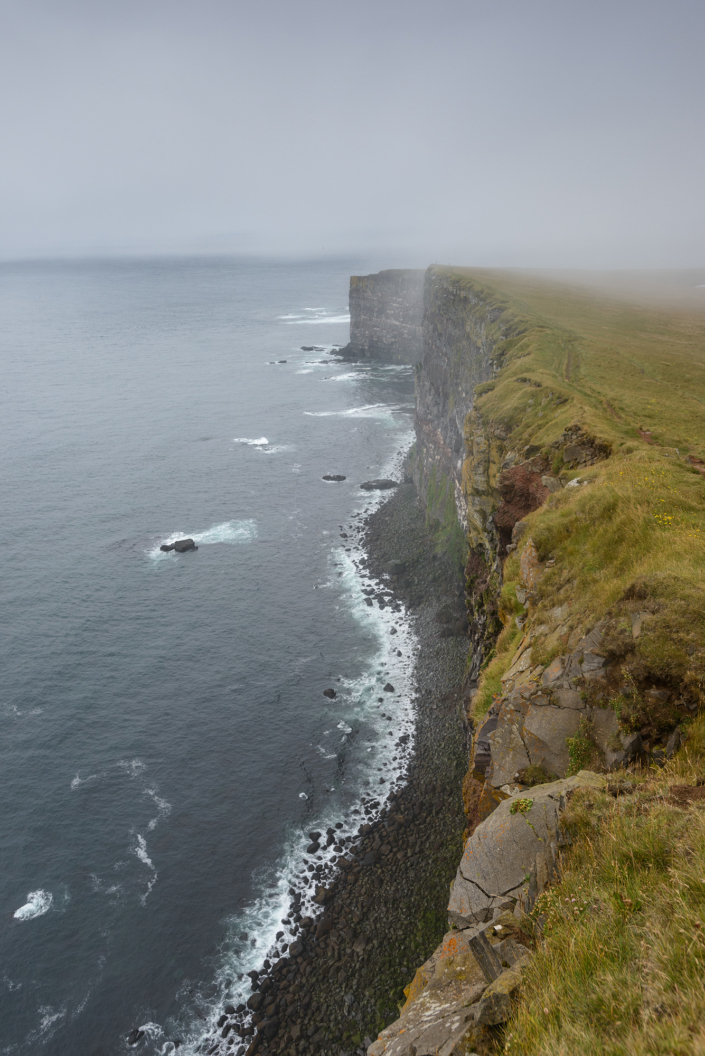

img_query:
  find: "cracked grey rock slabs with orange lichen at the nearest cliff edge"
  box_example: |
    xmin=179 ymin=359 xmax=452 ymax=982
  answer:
xmin=367 ymin=770 xmax=607 ymax=1056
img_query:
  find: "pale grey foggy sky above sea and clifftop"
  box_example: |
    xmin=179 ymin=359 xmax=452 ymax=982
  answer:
xmin=0 ymin=0 xmax=705 ymax=267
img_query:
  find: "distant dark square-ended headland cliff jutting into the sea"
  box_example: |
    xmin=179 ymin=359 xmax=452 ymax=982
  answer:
xmin=344 ymin=269 xmax=424 ymax=363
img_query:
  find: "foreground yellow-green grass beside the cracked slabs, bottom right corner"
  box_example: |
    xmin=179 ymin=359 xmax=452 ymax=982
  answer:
xmin=497 ymin=717 xmax=705 ymax=1056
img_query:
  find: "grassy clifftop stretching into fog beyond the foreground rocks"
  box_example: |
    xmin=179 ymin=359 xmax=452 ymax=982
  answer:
xmin=447 ymin=268 xmax=705 ymax=714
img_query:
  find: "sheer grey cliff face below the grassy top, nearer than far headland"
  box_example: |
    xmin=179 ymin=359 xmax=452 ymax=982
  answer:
xmin=411 ymin=267 xmax=533 ymax=668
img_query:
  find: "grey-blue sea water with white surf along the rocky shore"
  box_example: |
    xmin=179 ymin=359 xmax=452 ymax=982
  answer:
xmin=0 ymin=259 xmax=415 ymax=1056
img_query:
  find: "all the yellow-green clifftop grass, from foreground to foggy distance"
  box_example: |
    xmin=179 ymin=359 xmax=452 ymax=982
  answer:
xmin=446 ymin=268 xmax=705 ymax=1056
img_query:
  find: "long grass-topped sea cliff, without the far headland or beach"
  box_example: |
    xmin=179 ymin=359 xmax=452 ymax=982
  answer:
xmin=368 ymin=267 xmax=705 ymax=1056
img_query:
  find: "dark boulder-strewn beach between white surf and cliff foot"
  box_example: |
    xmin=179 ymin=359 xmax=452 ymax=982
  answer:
xmin=204 ymin=483 xmax=469 ymax=1056
